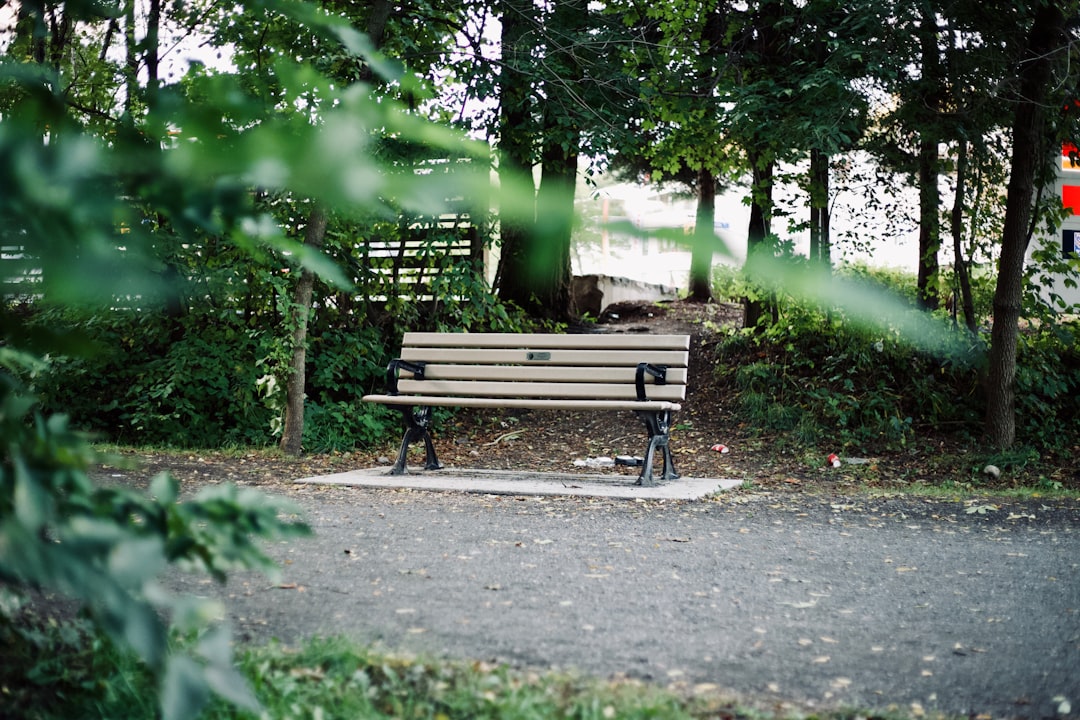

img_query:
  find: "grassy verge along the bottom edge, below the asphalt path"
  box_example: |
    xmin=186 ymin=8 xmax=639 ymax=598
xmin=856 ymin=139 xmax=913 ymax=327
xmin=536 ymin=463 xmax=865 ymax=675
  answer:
xmin=0 ymin=612 xmax=920 ymax=720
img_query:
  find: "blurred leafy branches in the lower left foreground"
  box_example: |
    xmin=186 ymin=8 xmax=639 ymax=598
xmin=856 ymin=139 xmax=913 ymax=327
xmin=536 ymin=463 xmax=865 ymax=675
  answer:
xmin=0 ymin=348 xmax=308 ymax=718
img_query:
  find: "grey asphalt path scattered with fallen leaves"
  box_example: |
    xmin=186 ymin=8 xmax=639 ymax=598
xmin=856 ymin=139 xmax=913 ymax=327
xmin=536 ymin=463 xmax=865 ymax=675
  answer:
xmin=172 ymin=487 xmax=1080 ymax=718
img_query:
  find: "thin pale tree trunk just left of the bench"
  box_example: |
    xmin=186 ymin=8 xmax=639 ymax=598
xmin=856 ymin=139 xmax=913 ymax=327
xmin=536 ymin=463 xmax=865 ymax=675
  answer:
xmin=280 ymin=205 xmax=327 ymax=456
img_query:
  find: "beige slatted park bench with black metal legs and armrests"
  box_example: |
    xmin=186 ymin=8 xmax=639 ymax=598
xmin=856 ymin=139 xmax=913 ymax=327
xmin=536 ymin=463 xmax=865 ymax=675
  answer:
xmin=363 ymin=332 xmax=690 ymax=486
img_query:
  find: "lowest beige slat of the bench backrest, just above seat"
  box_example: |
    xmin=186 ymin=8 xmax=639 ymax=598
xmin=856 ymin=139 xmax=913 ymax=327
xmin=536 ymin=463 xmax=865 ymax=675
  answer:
xmin=397 ymin=380 xmax=686 ymax=400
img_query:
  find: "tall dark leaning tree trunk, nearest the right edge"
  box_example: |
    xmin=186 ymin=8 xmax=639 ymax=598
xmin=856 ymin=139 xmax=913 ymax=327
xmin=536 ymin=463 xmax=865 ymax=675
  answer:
xmin=985 ymin=3 xmax=1067 ymax=449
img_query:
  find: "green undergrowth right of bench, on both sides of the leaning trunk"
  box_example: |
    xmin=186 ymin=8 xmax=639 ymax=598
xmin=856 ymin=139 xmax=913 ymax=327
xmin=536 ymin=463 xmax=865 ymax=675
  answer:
xmin=716 ymin=268 xmax=1080 ymax=464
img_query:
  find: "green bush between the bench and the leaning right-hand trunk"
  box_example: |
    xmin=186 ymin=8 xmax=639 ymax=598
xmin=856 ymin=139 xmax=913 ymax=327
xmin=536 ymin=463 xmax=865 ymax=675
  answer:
xmin=717 ymin=305 xmax=981 ymax=451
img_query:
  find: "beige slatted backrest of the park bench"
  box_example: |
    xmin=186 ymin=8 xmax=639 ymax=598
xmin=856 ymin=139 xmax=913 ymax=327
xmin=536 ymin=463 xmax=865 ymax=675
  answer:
xmin=397 ymin=332 xmax=690 ymax=403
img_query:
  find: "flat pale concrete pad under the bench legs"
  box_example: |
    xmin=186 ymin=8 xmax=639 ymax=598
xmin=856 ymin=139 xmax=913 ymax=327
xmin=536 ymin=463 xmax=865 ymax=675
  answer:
xmin=296 ymin=467 xmax=742 ymax=500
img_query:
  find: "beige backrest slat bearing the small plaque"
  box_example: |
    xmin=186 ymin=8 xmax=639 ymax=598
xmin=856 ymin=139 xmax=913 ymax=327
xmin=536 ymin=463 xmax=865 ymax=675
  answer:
xmin=401 ymin=347 xmax=689 ymax=367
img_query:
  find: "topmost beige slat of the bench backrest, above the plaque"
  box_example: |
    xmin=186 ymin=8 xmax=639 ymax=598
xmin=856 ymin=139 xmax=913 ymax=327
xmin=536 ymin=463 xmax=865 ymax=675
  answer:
xmin=402 ymin=332 xmax=690 ymax=352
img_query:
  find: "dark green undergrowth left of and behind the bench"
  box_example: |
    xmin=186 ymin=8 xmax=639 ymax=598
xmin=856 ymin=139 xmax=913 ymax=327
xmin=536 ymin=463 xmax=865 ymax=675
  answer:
xmin=19 ymin=280 xmax=527 ymax=452
